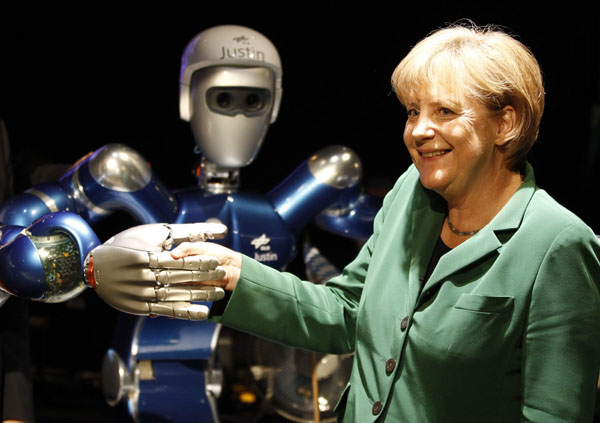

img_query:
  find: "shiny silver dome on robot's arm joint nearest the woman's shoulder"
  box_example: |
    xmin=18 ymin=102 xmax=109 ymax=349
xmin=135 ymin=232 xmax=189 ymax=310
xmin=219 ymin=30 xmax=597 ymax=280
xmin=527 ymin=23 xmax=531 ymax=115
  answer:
xmin=308 ymin=145 xmax=362 ymax=189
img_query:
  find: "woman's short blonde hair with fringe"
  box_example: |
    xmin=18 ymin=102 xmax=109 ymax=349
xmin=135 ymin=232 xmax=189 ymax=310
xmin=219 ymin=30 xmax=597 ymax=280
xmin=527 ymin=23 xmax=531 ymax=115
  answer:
xmin=392 ymin=23 xmax=544 ymax=171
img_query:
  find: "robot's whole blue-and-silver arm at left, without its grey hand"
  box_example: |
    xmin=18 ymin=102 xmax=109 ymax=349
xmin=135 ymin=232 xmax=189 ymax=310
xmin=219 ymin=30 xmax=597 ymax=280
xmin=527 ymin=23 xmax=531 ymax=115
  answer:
xmin=0 ymin=144 xmax=183 ymax=302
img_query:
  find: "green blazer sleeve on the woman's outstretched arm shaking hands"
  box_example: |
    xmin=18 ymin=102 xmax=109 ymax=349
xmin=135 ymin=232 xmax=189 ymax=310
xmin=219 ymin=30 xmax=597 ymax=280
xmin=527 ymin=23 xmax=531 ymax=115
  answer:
xmin=211 ymin=167 xmax=409 ymax=354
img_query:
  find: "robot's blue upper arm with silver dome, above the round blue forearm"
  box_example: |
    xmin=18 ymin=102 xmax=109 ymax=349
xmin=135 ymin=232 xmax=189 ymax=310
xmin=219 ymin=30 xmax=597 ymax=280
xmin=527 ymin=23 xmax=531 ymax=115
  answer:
xmin=0 ymin=144 xmax=177 ymax=226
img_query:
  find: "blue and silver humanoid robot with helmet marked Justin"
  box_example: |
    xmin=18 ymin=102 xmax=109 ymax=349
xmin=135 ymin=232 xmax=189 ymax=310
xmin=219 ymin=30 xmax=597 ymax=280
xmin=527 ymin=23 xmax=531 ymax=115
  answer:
xmin=0 ymin=25 xmax=379 ymax=422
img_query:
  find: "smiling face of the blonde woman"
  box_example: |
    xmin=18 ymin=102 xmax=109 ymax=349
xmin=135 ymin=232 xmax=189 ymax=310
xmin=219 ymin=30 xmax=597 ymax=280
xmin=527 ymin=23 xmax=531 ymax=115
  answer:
xmin=404 ymin=87 xmax=505 ymax=201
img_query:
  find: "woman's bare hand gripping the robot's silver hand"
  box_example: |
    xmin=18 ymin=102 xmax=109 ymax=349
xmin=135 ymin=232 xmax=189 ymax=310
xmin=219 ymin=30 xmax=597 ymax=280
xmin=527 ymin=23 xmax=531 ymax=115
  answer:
xmin=171 ymin=242 xmax=242 ymax=291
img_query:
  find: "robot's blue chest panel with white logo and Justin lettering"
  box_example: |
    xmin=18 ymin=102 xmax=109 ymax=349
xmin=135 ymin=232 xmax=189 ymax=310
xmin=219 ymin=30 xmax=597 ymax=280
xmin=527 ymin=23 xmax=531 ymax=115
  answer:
xmin=179 ymin=194 xmax=296 ymax=269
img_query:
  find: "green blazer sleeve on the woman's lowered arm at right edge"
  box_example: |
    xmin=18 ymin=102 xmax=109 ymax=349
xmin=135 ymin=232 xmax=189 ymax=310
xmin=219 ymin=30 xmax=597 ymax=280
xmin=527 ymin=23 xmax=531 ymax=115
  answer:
xmin=522 ymin=223 xmax=600 ymax=423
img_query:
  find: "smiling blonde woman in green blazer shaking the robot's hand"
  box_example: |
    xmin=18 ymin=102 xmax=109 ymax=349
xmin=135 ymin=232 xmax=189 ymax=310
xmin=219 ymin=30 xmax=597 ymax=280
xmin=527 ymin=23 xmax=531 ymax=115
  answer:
xmin=172 ymin=26 xmax=600 ymax=423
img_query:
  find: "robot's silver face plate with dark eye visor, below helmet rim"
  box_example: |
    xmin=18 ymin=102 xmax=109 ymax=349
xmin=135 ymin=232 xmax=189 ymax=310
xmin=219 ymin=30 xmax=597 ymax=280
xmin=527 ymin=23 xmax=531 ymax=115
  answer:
xmin=190 ymin=66 xmax=275 ymax=169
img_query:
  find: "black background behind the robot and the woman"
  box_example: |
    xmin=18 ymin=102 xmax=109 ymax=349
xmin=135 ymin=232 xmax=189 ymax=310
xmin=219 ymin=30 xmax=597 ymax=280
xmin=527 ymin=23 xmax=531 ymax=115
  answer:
xmin=0 ymin=2 xmax=600 ymax=421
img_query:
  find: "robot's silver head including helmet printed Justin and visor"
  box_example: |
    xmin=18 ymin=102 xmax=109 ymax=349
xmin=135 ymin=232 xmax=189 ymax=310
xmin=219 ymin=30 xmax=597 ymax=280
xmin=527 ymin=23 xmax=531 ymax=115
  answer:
xmin=179 ymin=25 xmax=282 ymax=168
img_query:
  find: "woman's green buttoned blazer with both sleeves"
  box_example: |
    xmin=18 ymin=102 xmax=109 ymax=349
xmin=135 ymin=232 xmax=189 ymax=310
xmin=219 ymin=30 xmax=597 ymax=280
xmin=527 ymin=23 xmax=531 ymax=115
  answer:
xmin=214 ymin=166 xmax=600 ymax=423
